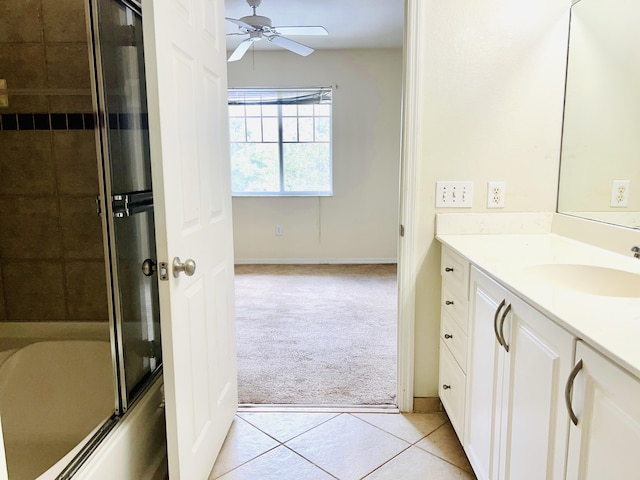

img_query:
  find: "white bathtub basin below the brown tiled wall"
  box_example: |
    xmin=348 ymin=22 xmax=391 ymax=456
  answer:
xmin=0 ymin=340 xmax=115 ymax=480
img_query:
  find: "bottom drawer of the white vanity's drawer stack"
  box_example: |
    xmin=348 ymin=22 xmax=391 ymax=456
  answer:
xmin=439 ymin=339 xmax=466 ymax=440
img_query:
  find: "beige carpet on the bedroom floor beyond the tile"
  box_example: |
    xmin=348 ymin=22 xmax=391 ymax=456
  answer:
xmin=236 ymin=265 xmax=397 ymax=405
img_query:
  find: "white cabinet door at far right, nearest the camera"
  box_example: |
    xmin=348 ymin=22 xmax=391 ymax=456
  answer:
xmin=567 ymin=342 xmax=640 ymax=480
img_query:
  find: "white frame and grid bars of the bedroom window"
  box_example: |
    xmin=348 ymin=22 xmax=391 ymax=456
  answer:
xmin=228 ymin=87 xmax=333 ymax=197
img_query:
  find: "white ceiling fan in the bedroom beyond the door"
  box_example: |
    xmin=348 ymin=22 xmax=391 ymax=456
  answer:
xmin=226 ymin=0 xmax=329 ymax=62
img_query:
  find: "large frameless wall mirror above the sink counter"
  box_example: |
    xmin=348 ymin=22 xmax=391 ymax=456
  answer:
xmin=558 ymin=0 xmax=640 ymax=228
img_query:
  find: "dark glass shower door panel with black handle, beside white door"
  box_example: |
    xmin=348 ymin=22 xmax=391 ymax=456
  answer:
xmin=94 ymin=0 xmax=162 ymax=412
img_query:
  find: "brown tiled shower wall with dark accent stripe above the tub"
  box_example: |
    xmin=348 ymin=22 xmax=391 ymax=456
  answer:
xmin=0 ymin=0 xmax=108 ymax=322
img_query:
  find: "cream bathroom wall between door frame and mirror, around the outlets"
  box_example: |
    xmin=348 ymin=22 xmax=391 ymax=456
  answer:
xmin=408 ymin=0 xmax=570 ymax=397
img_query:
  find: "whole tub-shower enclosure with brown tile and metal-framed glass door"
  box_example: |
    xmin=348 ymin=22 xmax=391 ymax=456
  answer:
xmin=0 ymin=0 xmax=162 ymax=474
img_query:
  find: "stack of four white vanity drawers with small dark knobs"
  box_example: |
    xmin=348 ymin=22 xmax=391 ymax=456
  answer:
xmin=439 ymin=248 xmax=469 ymax=438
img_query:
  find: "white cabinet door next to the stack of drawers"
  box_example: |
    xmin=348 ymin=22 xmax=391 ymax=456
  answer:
xmin=464 ymin=269 xmax=507 ymax=480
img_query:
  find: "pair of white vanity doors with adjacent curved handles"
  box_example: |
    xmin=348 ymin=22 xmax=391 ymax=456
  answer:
xmin=463 ymin=267 xmax=575 ymax=480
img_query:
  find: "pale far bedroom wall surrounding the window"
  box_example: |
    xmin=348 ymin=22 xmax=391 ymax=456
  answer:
xmin=228 ymin=49 xmax=402 ymax=262
